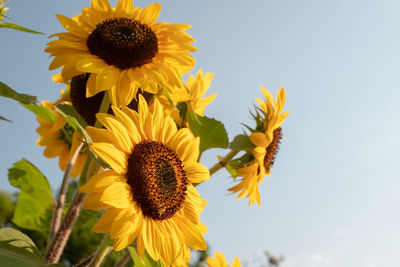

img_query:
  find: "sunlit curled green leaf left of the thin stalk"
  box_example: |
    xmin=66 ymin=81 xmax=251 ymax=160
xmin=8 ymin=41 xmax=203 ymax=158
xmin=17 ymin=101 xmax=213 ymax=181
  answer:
xmin=8 ymin=159 xmax=54 ymax=231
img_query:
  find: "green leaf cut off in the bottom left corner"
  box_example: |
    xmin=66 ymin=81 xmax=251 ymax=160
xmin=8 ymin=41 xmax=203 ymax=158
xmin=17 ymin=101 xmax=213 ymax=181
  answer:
xmin=0 ymin=228 xmax=46 ymax=267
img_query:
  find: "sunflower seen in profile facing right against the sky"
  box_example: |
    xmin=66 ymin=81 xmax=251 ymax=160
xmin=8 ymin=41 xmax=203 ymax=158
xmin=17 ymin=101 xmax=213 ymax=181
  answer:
xmin=229 ymin=86 xmax=289 ymax=205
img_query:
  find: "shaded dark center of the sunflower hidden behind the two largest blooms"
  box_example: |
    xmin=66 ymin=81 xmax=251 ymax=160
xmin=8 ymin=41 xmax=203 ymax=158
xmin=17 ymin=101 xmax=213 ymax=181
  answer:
xmin=70 ymin=73 xmax=153 ymax=126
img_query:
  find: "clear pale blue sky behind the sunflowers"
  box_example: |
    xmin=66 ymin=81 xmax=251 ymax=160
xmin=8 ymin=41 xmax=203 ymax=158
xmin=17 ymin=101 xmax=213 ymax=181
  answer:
xmin=0 ymin=0 xmax=400 ymax=267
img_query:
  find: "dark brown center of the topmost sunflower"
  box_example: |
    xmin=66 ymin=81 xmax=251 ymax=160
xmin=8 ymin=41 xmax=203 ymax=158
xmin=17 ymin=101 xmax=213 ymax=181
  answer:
xmin=86 ymin=18 xmax=158 ymax=70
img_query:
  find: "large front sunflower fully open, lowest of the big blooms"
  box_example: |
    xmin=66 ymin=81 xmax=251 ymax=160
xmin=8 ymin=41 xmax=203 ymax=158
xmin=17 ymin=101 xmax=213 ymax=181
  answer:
xmin=80 ymin=95 xmax=210 ymax=266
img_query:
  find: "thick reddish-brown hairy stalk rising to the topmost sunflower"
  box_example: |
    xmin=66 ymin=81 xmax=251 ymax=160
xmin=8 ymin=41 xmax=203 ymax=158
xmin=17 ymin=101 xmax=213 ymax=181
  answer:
xmin=45 ymin=92 xmax=110 ymax=264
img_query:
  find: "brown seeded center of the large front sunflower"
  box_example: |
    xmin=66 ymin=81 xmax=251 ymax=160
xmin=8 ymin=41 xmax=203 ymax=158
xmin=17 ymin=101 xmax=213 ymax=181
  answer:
xmin=126 ymin=141 xmax=188 ymax=220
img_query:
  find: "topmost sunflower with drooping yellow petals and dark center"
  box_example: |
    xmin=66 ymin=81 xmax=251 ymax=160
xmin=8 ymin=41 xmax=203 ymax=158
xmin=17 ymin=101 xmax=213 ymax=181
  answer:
xmin=45 ymin=0 xmax=196 ymax=107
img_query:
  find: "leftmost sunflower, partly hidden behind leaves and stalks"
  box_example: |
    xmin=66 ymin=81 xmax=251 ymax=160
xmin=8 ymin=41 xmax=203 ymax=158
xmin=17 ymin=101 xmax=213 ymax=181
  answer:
xmin=36 ymin=101 xmax=86 ymax=177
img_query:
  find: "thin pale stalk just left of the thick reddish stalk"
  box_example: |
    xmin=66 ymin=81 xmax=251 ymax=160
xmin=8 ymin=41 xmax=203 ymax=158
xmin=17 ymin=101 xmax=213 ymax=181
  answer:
xmin=48 ymin=143 xmax=83 ymax=241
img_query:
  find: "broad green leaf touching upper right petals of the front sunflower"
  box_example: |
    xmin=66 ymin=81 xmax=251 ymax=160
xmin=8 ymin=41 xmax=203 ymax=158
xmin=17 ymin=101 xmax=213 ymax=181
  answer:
xmin=187 ymin=111 xmax=229 ymax=152
